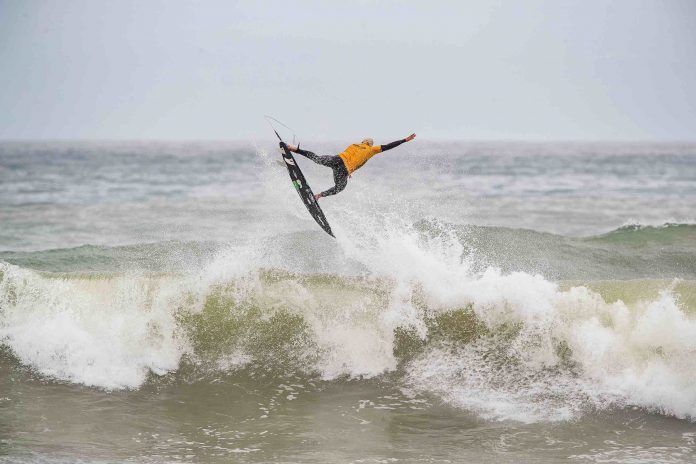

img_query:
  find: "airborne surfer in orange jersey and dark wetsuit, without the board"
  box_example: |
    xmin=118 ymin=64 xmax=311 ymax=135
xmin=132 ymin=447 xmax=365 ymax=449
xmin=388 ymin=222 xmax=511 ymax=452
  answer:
xmin=287 ymin=134 xmax=416 ymax=200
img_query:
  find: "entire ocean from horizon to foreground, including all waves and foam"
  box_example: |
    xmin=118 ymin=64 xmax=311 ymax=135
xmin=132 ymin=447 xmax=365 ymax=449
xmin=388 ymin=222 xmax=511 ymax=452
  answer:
xmin=0 ymin=138 xmax=696 ymax=463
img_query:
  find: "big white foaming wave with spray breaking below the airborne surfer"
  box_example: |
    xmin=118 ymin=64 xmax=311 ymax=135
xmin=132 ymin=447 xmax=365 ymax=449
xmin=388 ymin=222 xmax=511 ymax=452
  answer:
xmin=0 ymin=222 xmax=696 ymax=422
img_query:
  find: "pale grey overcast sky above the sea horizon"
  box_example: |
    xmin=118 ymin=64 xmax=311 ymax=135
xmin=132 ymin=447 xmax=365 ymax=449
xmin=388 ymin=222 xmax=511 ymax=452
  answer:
xmin=0 ymin=0 xmax=696 ymax=141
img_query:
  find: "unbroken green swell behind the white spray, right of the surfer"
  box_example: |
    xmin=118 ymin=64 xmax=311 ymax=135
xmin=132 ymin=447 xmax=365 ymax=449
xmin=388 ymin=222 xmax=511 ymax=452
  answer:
xmin=417 ymin=221 xmax=696 ymax=280
